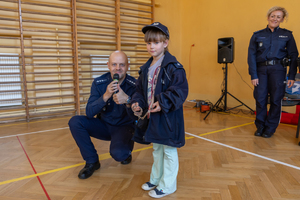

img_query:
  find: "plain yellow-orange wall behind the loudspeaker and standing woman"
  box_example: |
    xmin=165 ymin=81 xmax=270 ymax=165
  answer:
xmin=155 ymin=0 xmax=300 ymax=109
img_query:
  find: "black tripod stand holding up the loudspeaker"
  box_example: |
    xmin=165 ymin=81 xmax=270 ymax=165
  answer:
xmin=204 ymin=63 xmax=254 ymax=120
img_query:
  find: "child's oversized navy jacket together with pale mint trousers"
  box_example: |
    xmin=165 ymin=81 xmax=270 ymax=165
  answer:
xmin=131 ymin=51 xmax=188 ymax=193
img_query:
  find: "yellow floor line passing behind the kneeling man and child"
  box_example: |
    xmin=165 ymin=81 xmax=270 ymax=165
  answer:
xmin=0 ymin=122 xmax=254 ymax=185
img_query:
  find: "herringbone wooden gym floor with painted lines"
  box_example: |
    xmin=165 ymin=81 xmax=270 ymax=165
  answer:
xmin=0 ymin=104 xmax=300 ymax=200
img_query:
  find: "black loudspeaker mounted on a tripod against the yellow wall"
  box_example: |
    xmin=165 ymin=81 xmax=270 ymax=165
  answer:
xmin=218 ymin=37 xmax=234 ymax=63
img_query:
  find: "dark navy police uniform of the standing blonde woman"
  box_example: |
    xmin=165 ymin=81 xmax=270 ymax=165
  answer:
xmin=248 ymin=27 xmax=298 ymax=133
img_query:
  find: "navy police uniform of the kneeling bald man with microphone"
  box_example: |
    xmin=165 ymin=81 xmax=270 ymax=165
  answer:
xmin=69 ymin=72 xmax=136 ymax=163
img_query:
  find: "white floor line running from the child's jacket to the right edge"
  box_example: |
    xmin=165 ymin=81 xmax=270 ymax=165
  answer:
xmin=185 ymin=132 xmax=300 ymax=170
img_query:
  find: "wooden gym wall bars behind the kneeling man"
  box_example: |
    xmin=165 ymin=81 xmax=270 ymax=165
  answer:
xmin=0 ymin=0 xmax=154 ymax=123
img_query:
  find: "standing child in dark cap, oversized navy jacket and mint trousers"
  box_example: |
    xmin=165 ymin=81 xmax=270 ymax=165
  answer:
xmin=131 ymin=22 xmax=188 ymax=198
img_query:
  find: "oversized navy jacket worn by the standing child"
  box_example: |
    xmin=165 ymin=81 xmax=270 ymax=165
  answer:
xmin=131 ymin=51 xmax=188 ymax=147
